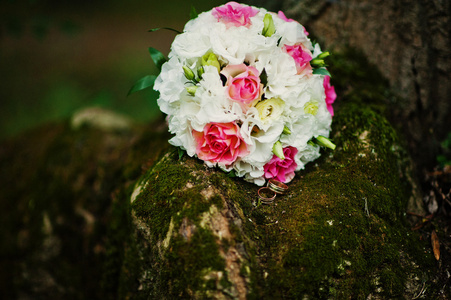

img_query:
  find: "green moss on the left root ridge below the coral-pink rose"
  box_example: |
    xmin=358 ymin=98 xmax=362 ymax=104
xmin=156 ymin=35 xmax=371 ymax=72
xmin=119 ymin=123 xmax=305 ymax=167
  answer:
xmin=122 ymin=149 xmax=240 ymax=298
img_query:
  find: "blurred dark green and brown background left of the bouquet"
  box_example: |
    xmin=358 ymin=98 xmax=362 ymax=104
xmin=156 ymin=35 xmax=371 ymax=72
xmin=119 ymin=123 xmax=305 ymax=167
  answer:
xmin=0 ymin=0 xmax=228 ymax=140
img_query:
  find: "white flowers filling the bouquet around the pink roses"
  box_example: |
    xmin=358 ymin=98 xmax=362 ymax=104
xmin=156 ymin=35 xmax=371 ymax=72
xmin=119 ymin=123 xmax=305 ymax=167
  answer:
xmin=154 ymin=2 xmax=338 ymax=185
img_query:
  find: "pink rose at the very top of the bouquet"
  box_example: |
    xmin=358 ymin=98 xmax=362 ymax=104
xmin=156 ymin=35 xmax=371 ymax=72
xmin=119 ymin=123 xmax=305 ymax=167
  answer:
xmin=212 ymin=1 xmax=258 ymax=28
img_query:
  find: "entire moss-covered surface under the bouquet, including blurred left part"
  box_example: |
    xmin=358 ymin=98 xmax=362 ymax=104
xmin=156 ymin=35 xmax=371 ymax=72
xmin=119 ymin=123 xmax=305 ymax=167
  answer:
xmin=0 ymin=51 xmax=444 ymax=299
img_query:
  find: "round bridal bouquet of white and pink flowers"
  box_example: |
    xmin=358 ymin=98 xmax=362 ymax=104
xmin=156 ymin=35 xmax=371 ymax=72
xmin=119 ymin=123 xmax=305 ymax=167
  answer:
xmin=136 ymin=2 xmax=336 ymax=185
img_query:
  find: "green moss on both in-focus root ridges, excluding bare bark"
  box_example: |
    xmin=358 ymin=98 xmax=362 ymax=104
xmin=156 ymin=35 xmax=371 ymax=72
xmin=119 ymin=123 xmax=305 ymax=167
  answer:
xmin=124 ymin=104 xmax=434 ymax=299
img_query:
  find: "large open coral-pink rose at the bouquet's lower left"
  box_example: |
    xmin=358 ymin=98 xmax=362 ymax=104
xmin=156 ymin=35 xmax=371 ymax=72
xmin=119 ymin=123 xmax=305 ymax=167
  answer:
xmin=193 ymin=122 xmax=249 ymax=165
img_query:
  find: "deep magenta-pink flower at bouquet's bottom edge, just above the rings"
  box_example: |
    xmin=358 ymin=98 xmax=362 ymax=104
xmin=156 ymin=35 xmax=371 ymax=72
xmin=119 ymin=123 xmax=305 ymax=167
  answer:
xmin=263 ymin=146 xmax=298 ymax=183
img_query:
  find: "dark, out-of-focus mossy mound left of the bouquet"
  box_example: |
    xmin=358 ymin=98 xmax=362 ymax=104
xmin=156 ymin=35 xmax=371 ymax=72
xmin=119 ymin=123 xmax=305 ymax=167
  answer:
xmin=0 ymin=109 xmax=168 ymax=299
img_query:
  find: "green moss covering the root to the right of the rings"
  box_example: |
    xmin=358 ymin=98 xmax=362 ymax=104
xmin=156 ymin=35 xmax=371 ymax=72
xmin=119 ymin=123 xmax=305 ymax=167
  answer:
xmin=247 ymin=104 xmax=431 ymax=298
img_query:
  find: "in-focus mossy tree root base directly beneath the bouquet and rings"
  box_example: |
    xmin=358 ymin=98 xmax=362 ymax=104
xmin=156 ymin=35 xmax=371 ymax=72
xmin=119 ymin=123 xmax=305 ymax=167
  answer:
xmin=120 ymin=104 xmax=433 ymax=299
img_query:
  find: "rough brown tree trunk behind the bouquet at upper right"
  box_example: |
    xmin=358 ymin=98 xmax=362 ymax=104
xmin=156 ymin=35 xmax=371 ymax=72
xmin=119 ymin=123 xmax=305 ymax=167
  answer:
xmin=247 ymin=0 xmax=451 ymax=167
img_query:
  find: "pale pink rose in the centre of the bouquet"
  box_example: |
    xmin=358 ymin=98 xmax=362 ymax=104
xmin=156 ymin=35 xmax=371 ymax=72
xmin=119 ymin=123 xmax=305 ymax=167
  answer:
xmin=221 ymin=64 xmax=263 ymax=110
